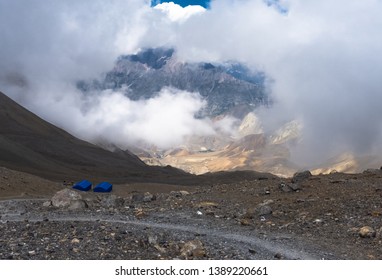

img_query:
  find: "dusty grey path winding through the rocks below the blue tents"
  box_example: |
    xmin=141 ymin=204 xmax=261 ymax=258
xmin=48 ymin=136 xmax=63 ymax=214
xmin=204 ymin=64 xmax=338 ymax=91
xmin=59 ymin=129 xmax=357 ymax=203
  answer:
xmin=0 ymin=199 xmax=325 ymax=259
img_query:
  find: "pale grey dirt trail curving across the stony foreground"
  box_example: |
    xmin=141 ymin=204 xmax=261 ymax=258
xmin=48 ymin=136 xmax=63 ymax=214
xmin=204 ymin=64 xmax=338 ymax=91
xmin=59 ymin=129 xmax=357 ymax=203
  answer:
xmin=0 ymin=199 xmax=322 ymax=259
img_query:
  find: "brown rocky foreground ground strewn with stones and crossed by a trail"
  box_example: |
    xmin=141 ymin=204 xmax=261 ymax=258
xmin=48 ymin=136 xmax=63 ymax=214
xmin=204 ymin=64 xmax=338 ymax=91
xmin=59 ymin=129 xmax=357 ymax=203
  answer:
xmin=0 ymin=168 xmax=382 ymax=259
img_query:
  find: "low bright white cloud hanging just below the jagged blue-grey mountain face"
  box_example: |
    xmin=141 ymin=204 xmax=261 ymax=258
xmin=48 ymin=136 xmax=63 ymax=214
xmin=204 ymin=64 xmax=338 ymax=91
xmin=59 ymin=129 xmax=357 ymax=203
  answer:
xmin=23 ymin=86 xmax=215 ymax=148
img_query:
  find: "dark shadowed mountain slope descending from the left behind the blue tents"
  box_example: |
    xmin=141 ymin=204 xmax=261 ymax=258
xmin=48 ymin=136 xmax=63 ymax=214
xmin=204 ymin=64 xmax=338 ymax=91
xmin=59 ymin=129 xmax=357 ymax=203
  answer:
xmin=0 ymin=92 xmax=189 ymax=182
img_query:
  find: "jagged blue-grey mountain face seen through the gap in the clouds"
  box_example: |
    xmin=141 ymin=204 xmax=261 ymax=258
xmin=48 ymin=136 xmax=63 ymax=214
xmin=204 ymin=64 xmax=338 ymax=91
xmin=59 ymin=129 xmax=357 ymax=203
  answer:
xmin=78 ymin=48 xmax=269 ymax=118
